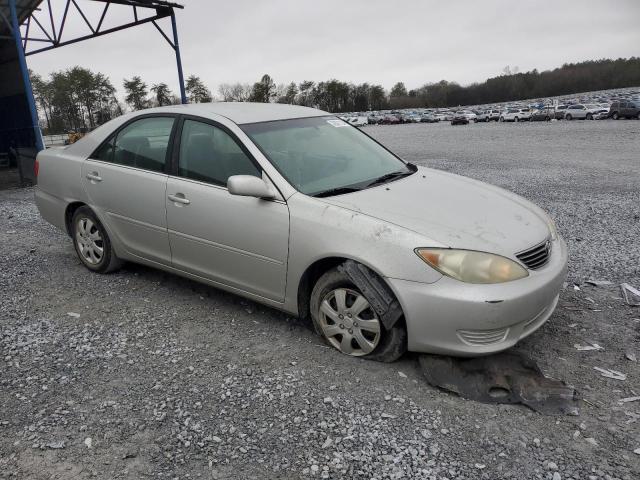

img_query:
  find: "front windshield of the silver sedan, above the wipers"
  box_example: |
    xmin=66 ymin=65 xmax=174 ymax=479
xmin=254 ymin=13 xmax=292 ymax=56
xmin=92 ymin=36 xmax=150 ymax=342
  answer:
xmin=241 ymin=116 xmax=415 ymax=196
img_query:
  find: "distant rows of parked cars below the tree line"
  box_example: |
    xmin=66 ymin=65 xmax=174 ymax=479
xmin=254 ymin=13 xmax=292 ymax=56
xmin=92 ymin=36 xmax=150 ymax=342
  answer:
xmin=340 ymin=91 xmax=640 ymax=127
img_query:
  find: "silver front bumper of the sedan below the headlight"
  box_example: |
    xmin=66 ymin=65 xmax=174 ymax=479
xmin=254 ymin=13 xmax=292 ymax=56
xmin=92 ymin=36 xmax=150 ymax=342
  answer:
xmin=387 ymin=238 xmax=567 ymax=356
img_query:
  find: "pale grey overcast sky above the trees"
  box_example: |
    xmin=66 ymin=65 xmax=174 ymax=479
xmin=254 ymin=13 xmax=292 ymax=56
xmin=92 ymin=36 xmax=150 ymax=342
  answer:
xmin=27 ymin=0 xmax=640 ymax=93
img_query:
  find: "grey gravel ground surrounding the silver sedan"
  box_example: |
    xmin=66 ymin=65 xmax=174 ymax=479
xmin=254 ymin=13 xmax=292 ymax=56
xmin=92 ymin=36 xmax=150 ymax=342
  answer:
xmin=0 ymin=121 xmax=640 ymax=480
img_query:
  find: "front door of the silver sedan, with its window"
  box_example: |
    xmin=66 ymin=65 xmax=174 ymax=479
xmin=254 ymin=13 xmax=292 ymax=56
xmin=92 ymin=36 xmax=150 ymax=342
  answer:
xmin=166 ymin=119 xmax=289 ymax=301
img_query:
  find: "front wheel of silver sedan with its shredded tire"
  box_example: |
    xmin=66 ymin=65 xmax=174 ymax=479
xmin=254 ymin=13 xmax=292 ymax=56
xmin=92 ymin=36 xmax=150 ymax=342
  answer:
xmin=310 ymin=268 xmax=407 ymax=362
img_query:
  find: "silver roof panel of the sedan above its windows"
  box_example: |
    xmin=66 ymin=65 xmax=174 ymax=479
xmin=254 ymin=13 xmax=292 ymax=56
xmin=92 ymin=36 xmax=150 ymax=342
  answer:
xmin=136 ymin=102 xmax=331 ymax=125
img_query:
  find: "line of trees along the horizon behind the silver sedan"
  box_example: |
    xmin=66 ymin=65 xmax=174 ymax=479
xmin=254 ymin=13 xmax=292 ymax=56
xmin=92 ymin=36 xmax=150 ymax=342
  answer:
xmin=31 ymin=57 xmax=640 ymax=133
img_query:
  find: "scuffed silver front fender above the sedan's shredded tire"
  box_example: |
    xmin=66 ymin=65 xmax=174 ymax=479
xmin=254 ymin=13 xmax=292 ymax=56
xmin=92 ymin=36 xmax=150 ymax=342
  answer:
xmin=287 ymin=193 xmax=444 ymax=311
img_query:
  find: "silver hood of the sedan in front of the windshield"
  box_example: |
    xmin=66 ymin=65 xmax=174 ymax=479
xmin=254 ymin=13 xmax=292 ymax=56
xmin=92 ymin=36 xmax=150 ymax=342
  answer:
xmin=322 ymin=167 xmax=550 ymax=257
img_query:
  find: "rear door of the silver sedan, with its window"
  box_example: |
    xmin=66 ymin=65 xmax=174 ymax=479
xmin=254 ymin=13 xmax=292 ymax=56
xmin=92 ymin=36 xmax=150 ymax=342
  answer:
xmin=82 ymin=115 xmax=176 ymax=265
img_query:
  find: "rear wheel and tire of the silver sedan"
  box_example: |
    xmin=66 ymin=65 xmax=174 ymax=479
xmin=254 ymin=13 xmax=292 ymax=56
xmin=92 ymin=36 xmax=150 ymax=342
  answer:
xmin=71 ymin=206 xmax=122 ymax=273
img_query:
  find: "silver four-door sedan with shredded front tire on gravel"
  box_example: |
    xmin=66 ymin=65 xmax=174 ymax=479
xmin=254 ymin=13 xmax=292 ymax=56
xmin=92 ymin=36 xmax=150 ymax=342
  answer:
xmin=36 ymin=103 xmax=567 ymax=361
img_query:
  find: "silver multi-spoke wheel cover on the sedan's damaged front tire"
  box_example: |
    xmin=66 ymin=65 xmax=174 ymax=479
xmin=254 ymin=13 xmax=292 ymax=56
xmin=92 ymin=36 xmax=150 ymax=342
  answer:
xmin=318 ymin=288 xmax=381 ymax=357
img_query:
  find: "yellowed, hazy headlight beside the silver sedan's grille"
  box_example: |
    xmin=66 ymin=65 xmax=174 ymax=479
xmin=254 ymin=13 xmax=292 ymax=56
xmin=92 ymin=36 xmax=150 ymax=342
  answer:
xmin=415 ymin=248 xmax=529 ymax=283
